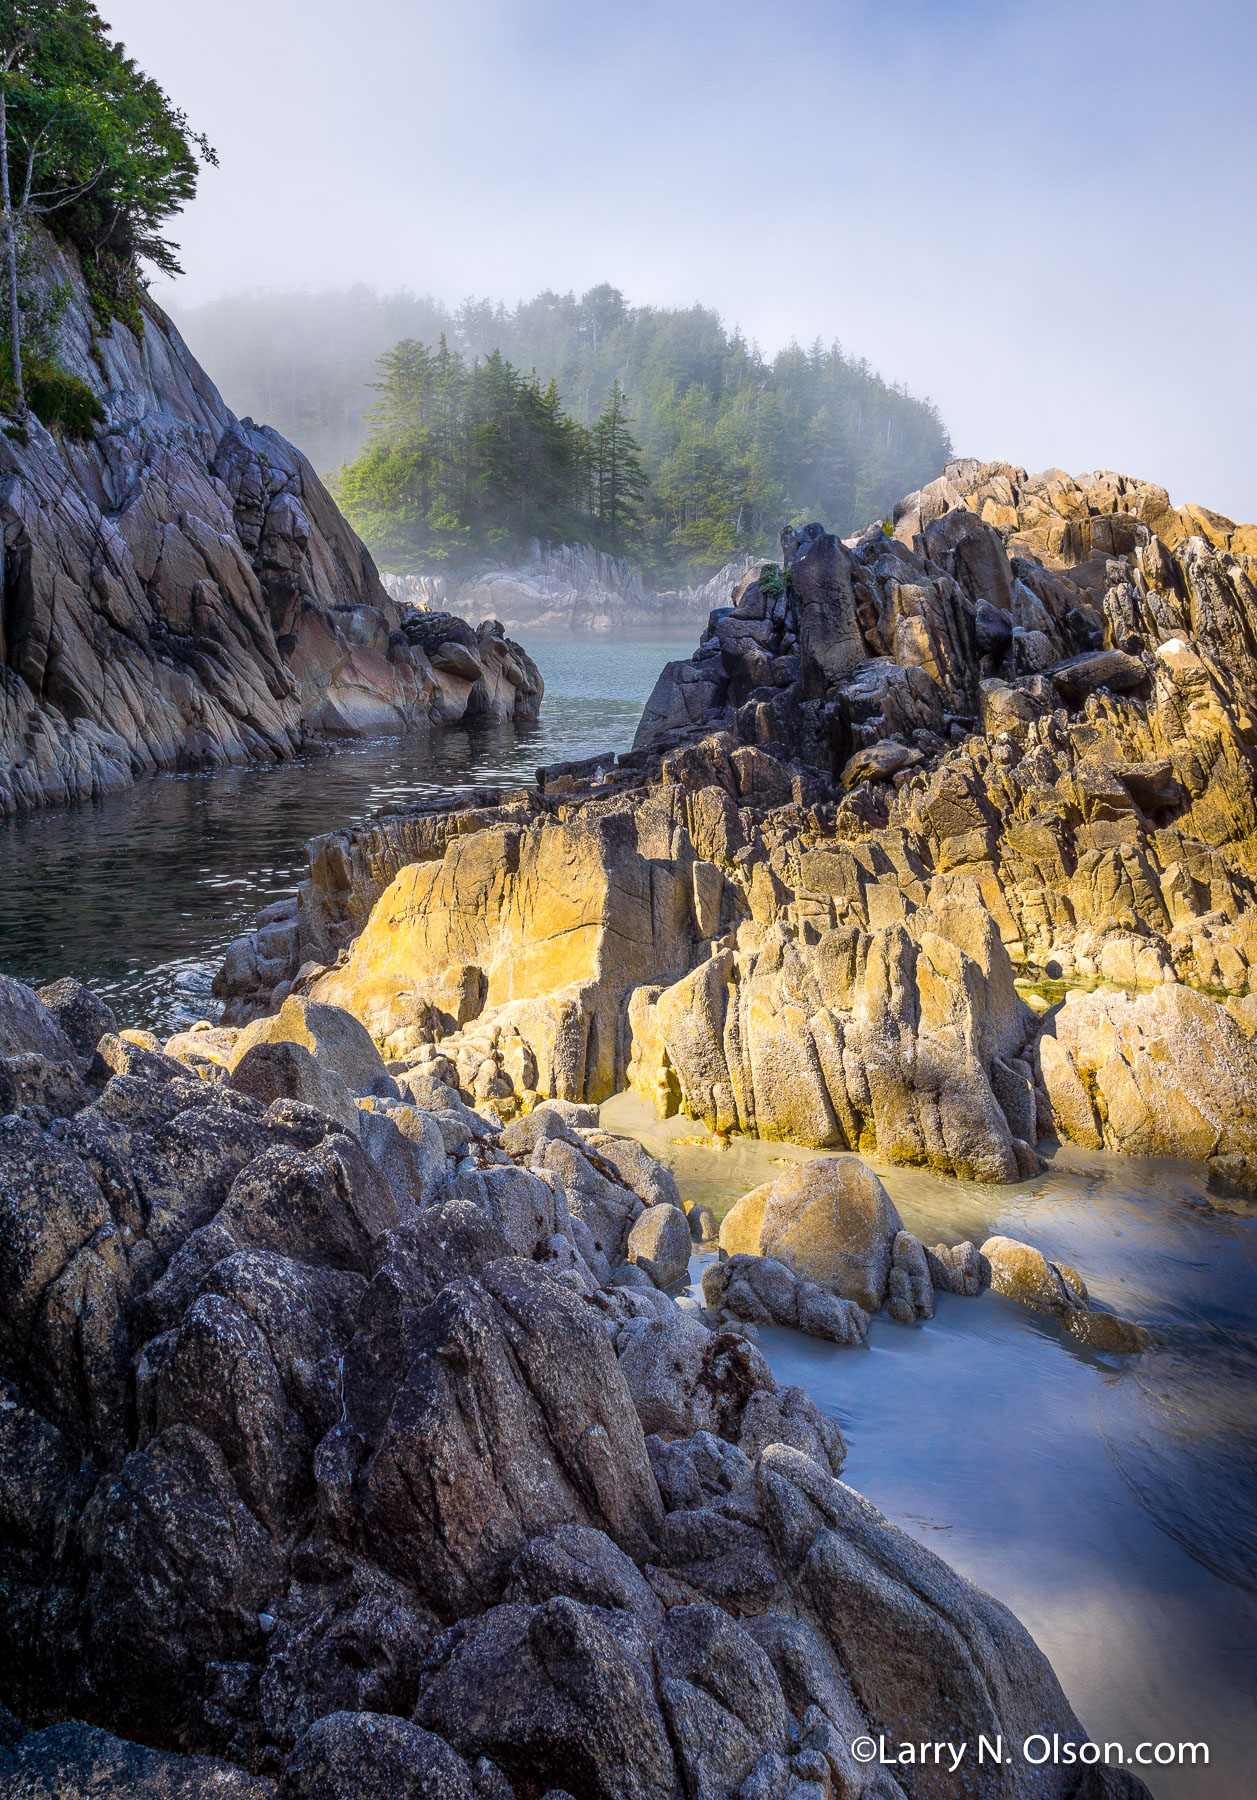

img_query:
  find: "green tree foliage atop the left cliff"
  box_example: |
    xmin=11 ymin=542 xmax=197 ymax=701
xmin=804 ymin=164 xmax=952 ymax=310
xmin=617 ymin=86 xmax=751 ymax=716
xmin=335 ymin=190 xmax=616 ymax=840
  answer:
xmin=0 ymin=0 xmax=216 ymax=329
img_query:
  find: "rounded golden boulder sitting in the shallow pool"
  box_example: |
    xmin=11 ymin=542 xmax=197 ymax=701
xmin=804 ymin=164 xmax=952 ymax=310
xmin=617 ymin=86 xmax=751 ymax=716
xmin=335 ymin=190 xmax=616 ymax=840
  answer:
xmin=720 ymin=1157 xmax=902 ymax=1312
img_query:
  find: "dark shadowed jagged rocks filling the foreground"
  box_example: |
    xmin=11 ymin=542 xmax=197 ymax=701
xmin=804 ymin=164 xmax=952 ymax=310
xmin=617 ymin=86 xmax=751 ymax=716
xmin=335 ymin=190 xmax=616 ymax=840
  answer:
xmin=0 ymin=985 xmax=1145 ymax=1800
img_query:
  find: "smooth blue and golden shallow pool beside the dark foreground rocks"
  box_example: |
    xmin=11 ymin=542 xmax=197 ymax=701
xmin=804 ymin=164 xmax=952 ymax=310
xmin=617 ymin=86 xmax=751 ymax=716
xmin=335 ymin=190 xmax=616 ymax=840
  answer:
xmin=601 ymin=1094 xmax=1257 ymax=1800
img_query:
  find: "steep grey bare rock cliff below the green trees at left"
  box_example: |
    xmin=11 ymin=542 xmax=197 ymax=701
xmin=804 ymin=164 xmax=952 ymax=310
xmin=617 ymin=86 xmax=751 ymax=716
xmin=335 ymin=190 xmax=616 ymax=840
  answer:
xmin=0 ymin=241 xmax=542 ymax=814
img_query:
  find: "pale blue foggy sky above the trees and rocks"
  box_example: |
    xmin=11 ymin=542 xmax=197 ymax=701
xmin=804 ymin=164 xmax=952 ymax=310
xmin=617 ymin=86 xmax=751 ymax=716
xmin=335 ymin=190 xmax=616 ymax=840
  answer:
xmin=101 ymin=0 xmax=1257 ymax=520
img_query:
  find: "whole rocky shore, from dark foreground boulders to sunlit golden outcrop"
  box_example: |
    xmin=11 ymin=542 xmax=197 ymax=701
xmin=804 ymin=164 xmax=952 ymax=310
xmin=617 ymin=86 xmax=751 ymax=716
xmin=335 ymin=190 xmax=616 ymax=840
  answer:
xmin=0 ymin=446 xmax=1257 ymax=1800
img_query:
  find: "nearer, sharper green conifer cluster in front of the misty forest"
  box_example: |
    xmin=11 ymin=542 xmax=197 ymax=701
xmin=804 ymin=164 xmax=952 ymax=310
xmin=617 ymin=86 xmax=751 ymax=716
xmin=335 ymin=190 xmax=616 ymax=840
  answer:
xmin=333 ymin=337 xmax=647 ymax=572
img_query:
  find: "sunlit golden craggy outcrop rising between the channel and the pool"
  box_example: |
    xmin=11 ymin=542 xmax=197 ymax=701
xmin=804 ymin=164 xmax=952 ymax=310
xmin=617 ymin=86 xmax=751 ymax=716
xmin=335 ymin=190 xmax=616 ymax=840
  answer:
xmin=220 ymin=463 xmax=1257 ymax=1181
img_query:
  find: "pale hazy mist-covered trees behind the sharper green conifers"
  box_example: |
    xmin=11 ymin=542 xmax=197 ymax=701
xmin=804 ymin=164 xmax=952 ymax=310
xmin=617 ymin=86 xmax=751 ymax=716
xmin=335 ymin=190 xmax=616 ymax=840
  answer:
xmin=176 ymin=284 xmax=951 ymax=580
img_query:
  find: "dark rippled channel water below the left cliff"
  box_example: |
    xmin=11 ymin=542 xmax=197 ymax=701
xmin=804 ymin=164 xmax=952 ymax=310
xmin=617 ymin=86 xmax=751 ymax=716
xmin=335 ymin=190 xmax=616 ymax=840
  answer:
xmin=0 ymin=637 xmax=690 ymax=1035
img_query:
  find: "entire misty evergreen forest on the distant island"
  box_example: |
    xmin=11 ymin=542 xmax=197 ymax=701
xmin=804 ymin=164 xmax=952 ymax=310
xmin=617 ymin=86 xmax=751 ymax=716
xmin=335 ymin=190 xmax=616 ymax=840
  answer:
xmin=178 ymin=284 xmax=951 ymax=581
